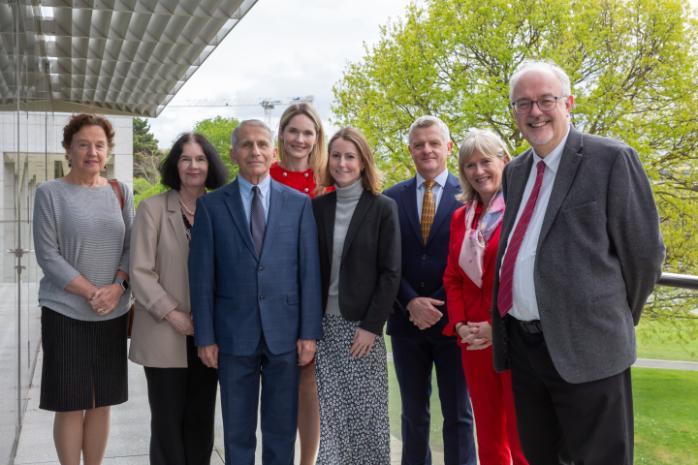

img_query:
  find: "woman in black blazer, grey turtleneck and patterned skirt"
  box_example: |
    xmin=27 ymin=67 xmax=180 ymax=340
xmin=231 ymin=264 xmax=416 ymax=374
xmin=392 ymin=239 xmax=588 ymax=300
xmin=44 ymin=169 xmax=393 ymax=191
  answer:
xmin=313 ymin=128 xmax=401 ymax=465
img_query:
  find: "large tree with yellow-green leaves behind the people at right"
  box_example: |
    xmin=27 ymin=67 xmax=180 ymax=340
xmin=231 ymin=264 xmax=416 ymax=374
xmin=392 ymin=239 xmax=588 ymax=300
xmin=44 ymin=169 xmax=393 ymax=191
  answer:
xmin=333 ymin=0 xmax=698 ymax=314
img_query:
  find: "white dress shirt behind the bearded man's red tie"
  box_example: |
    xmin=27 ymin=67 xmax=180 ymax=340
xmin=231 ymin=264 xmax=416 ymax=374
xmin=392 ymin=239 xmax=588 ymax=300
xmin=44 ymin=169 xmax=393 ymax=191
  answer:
xmin=507 ymin=126 xmax=570 ymax=321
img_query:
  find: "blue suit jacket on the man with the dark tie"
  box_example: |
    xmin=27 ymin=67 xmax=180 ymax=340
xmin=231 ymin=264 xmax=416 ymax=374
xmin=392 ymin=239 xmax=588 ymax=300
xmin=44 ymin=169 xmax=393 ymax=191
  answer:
xmin=189 ymin=180 xmax=322 ymax=356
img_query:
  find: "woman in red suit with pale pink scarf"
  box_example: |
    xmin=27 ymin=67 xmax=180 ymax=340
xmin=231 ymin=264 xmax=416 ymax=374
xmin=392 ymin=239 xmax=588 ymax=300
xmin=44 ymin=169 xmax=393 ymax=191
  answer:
xmin=444 ymin=129 xmax=527 ymax=465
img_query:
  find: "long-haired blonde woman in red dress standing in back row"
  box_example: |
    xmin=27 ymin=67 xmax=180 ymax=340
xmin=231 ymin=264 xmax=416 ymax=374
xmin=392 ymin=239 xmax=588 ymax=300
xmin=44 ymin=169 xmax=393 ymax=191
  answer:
xmin=269 ymin=102 xmax=327 ymax=465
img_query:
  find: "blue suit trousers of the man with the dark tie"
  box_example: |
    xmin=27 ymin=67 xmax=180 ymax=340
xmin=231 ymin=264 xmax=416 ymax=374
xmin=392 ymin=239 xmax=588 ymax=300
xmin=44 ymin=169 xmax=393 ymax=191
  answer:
xmin=218 ymin=341 xmax=299 ymax=465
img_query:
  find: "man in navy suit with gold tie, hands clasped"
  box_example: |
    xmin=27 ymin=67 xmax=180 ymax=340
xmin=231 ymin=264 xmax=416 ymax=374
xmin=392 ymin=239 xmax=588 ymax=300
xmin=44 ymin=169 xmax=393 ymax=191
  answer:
xmin=385 ymin=116 xmax=477 ymax=465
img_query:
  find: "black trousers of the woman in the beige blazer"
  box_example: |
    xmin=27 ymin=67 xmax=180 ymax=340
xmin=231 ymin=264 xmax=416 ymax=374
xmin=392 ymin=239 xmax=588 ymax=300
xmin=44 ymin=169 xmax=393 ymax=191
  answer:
xmin=145 ymin=337 xmax=218 ymax=465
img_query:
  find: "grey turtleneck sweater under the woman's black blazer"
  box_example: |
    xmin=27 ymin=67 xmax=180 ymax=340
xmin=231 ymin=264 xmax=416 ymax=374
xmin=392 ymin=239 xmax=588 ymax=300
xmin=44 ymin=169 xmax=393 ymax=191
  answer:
xmin=325 ymin=178 xmax=364 ymax=315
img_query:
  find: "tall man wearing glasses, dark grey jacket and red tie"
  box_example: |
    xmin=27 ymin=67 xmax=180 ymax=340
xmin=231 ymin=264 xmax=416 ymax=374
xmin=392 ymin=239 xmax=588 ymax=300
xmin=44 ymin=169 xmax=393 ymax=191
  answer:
xmin=493 ymin=61 xmax=664 ymax=465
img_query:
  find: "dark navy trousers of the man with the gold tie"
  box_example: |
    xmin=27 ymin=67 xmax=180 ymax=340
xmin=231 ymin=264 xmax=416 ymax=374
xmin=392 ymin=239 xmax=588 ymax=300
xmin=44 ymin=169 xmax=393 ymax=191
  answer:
xmin=391 ymin=335 xmax=477 ymax=465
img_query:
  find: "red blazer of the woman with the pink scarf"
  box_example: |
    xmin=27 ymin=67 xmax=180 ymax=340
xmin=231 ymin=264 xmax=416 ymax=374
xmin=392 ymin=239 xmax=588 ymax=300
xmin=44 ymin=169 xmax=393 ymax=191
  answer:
xmin=443 ymin=204 xmax=502 ymax=336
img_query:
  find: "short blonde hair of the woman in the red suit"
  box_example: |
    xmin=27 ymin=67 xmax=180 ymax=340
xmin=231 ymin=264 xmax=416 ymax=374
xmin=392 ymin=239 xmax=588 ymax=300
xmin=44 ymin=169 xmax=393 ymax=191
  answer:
xmin=456 ymin=128 xmax=511 ymax=202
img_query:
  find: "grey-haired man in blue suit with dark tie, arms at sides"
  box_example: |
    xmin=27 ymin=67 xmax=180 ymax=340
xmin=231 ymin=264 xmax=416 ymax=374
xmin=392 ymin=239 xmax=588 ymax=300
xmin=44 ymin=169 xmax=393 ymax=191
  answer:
xmin=189 ymin=120 xmax=322 ymax=465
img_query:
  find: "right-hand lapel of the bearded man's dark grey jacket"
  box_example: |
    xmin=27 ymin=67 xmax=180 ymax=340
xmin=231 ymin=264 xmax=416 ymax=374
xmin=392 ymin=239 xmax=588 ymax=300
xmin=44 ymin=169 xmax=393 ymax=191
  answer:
xmin=536 ymin=128 xmax=583 ymax=250
